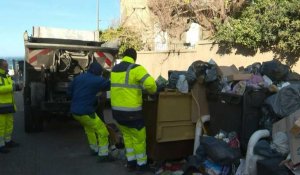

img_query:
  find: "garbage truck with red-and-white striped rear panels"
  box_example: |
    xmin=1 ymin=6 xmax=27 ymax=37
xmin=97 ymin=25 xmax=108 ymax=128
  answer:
xmin=22 ymin=27 xmax=118 ymax=132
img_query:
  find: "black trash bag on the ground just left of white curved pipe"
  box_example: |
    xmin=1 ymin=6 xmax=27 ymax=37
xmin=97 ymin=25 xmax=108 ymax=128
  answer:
xmin=200 ymin=136 xmax=241 ymax=165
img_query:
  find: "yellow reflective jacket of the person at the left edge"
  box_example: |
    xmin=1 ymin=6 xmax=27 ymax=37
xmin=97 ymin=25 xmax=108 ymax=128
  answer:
xmin=0 ymin=69 xmax=14 ymax=107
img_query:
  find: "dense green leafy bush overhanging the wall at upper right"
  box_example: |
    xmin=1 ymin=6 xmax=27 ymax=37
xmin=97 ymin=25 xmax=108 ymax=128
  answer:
xmin=214 ymin=0 xmax=300 ymax=65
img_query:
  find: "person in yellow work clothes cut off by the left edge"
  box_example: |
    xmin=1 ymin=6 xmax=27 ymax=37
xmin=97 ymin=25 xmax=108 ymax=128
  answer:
xmin=0 ymin=59 xmax=19 ymax=153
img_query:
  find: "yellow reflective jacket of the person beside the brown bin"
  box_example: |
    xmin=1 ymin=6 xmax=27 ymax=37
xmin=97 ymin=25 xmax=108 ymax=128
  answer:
xmin=110 ymin=56 xmax=157 ymax=111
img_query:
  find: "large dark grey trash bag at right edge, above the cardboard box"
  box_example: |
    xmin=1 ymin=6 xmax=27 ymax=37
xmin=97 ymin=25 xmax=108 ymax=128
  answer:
xmin=265 ymin=84 xmax=300 ymax=118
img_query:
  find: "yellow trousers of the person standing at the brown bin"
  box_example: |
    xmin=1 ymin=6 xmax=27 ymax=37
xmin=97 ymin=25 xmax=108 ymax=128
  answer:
xmin=118 ymin=125 xmax=147 ymax=165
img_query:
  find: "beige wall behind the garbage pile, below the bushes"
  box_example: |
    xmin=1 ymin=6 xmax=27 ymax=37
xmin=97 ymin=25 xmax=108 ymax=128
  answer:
xmin=137 ymin=41 xmax=300 ymax=78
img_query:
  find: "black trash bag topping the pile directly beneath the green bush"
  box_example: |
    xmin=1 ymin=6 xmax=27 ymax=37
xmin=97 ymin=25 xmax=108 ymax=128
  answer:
xmin=261 ymin=60 xmax=290 ymax=82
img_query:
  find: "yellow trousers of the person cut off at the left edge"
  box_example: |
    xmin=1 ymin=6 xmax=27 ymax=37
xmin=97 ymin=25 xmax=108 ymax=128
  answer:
xmin=0 ymin=114 xmax=14 ymax=147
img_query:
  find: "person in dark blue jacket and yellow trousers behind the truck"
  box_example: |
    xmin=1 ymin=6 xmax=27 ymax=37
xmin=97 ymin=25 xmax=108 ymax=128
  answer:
xmin=69 ymin=62 xmax=113 ymax=162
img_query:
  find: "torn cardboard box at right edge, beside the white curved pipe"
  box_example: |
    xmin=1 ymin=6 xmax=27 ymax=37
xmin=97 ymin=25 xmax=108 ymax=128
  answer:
xmin=272 ymin=110 xmax=300 ymax=164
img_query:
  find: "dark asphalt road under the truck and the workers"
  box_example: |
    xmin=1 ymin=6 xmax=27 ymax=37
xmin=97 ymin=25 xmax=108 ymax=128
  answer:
xmin=0 ymin=93 xmax=139 ymax=175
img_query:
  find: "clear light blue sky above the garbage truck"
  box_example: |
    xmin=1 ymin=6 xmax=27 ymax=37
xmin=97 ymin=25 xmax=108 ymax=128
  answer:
xmin=0 ymin=0 xmax=120 ymax=58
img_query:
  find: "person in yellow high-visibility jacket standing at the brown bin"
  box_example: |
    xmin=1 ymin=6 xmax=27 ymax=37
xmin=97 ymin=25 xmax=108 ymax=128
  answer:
xmin=110 ymin=48 xmax=157 ymax=171
